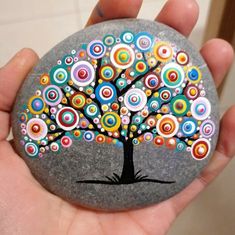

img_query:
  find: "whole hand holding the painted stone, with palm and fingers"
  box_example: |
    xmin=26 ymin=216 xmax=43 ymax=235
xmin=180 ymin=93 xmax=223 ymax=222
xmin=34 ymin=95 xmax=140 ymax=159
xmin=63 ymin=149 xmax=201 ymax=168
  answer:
xmin=0 ymin=0 xmax=235 ymax=235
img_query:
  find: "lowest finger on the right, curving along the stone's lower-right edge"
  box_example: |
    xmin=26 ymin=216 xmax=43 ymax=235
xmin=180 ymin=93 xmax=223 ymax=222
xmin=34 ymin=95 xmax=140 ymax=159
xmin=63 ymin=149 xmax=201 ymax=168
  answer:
xmin=169 ymin=106 xmax=235 ymax=214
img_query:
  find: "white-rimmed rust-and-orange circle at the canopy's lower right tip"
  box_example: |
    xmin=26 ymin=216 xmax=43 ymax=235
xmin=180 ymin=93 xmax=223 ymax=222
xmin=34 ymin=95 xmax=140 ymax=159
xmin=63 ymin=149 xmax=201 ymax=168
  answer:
xmin=191 ymin=138 xmax=211 ymax=160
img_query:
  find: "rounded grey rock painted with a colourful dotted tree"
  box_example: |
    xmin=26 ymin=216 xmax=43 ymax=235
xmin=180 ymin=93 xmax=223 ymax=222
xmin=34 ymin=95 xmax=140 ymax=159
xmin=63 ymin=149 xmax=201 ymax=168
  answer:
xmin=12 ymin=19 xmax=219 ymax=210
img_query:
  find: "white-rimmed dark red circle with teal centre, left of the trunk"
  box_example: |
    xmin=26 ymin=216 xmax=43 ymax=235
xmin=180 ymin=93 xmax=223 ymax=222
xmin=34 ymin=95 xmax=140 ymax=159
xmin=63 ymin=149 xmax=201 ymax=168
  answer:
xmin=56 ymin=107 xmax=79 ymax=131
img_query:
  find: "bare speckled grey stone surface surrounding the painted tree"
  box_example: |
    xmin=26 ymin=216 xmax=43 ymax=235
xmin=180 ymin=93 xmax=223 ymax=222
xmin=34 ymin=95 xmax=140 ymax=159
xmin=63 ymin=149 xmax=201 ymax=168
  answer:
xmin=12 ymin=19 xmax=219 ymax=211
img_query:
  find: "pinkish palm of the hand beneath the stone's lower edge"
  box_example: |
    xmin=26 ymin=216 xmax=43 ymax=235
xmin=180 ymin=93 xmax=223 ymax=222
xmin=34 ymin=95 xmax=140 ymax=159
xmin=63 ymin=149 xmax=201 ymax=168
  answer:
xmin=0 ymin=141 xmax=176 ymax=235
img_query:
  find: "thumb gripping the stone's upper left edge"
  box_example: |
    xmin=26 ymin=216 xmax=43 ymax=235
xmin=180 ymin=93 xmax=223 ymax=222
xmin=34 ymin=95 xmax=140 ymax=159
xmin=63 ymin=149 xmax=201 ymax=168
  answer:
xmin=0 ymin=49 xmax=38 ymax=112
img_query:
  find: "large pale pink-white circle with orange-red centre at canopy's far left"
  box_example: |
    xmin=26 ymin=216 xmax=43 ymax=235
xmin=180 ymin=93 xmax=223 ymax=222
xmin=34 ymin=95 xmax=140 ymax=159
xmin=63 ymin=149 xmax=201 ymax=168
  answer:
xmin=26 ymin=118 xmax=48 ymax=140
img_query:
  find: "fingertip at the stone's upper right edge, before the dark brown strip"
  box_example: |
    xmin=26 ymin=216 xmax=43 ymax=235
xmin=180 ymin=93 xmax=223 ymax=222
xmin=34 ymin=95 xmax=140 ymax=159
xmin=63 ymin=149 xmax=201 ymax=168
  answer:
xmin=201 ymin=39 xmax=234 ymax=87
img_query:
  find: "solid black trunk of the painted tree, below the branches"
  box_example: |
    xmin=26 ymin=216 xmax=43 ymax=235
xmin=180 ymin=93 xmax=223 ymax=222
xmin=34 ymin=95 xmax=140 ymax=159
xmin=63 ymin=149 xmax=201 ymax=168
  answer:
xmin=121 ymin=141 xmax=135 ymax=184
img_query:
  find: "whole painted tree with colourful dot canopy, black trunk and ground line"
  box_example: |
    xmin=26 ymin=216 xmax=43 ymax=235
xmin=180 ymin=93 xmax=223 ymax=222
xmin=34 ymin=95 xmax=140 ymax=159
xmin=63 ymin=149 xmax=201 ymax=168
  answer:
xmin=20 ymin=31 xmax=215 ymax=184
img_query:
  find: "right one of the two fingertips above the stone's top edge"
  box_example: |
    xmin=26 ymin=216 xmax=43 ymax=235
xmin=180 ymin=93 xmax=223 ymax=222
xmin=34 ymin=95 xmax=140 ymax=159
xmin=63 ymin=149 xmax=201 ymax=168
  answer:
xmin=156 ymin=0 xmax=199 ymax=37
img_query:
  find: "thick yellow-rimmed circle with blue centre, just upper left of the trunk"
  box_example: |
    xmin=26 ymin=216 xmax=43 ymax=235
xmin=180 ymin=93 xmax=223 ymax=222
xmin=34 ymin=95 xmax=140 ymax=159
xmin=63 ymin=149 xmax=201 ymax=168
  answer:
xmin=101 ymin=112 xmax=121 ymax=132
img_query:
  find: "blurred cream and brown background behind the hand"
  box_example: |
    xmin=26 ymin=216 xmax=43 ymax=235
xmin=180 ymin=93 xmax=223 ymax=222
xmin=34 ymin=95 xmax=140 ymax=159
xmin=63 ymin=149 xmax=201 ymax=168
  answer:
xmin=0 ymin=0 xmax=235 ymax=235
